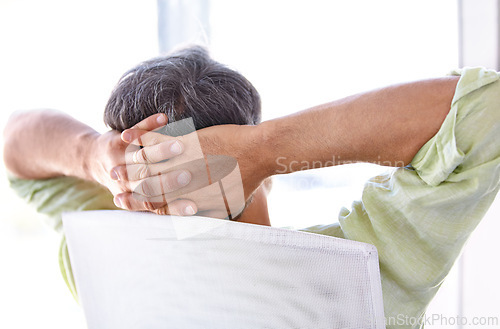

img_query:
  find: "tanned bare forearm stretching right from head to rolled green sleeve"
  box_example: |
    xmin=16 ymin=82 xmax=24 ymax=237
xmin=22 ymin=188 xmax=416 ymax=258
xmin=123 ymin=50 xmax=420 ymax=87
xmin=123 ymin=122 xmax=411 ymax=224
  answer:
xmin=257 ymin=77 xmax=458 ymax=175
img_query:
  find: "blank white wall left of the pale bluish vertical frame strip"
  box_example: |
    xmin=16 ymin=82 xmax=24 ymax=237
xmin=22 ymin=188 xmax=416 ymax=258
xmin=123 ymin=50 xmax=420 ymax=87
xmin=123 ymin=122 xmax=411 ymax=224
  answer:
xmin=0 ymin=0 xmax=158 ymax=329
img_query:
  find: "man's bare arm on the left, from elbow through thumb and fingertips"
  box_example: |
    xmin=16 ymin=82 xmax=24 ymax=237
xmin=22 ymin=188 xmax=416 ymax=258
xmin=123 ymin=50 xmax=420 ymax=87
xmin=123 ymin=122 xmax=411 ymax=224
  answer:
xmin=4 ymin=110 xmax=192 ymax=214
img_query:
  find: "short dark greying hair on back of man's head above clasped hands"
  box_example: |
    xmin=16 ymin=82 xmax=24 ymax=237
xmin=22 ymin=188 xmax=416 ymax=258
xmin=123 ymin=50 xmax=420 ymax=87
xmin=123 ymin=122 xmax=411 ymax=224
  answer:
xmin=104 ymin=46 xmax=261 ymax=131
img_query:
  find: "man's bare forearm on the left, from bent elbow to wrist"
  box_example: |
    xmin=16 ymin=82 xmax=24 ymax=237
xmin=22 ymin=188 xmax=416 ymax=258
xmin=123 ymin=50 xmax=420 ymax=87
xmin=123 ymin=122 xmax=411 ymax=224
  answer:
xmin=4 ymin=110 xmax=99 ymax=179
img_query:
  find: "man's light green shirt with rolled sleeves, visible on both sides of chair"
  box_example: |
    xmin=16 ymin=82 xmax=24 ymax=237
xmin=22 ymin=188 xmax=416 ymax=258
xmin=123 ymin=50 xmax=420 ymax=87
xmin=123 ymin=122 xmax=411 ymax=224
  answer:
xmin=11 ymin=68 xmax=500 ymax=328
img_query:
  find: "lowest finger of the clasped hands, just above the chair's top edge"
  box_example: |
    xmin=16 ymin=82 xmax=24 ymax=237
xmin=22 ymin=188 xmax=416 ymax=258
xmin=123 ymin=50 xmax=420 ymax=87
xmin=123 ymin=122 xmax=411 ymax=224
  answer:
xmin=114 ymin=192 xmax=198 ymax=216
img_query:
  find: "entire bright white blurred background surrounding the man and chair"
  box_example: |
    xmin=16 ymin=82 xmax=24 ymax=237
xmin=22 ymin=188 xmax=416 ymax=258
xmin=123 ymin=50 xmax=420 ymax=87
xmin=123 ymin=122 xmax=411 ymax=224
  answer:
xmin=0 ymin=0 xmax=500 ymax=329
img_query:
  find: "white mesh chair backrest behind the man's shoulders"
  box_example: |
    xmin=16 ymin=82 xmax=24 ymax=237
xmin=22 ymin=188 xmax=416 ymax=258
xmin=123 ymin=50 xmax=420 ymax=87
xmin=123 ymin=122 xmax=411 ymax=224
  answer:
xmin=63 ymin=211 xmax=385 ymax=329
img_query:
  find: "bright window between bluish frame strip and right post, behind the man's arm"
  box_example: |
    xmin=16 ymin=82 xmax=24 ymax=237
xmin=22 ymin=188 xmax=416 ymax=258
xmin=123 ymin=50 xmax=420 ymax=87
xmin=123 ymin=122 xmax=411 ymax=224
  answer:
xmin=159 ymin=0 xmax=458 ymax=228
